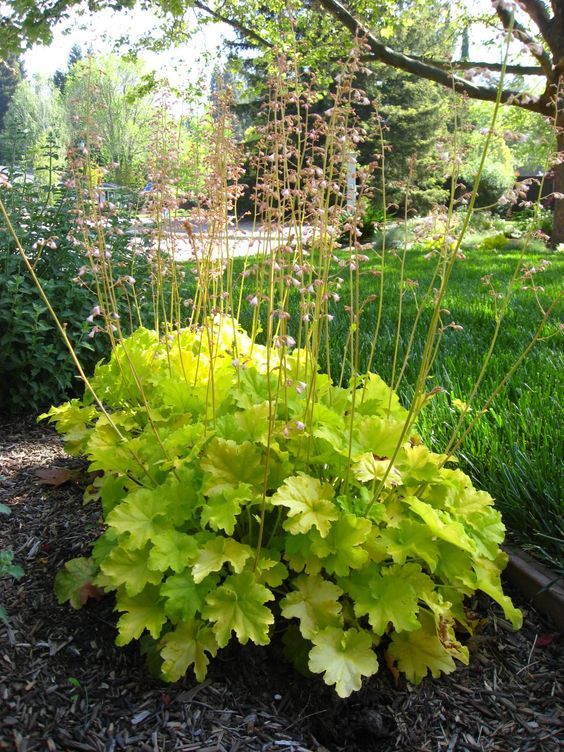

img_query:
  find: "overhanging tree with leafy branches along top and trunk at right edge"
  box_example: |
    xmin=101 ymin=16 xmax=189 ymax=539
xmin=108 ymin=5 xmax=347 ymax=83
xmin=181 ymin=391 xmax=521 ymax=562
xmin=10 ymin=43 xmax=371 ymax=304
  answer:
xmin=0 ymin=0 xmax=564 ymax=238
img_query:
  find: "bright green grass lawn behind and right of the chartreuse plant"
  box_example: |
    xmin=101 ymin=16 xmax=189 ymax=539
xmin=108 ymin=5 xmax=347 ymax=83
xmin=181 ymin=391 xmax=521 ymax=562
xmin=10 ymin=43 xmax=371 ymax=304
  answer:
xmin=183 ymin=235 xmax=564 ymax=572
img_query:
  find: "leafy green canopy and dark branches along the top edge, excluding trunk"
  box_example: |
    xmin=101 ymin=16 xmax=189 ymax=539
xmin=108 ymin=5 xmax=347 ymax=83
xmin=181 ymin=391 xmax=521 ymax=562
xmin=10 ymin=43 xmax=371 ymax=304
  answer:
xmin=0 ymin=0 xmax=564 ymax=116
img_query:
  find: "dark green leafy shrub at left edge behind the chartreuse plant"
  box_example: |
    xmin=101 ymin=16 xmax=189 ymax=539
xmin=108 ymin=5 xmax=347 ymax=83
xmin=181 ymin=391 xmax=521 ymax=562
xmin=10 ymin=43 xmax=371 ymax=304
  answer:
xmin=0 ymin=178 xmax=154 ymax=412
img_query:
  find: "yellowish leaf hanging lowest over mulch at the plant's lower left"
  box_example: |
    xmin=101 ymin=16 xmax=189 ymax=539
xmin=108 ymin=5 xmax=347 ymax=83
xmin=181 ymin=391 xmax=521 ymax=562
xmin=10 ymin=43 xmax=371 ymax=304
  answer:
xmin=160 ymin=619 xmax=218 ymax=682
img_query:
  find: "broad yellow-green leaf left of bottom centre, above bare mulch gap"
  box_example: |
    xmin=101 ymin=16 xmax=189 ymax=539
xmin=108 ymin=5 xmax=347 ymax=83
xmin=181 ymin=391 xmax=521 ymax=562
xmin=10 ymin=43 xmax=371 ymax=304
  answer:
xmin=202 ymin=571 xmax=274 ymax=648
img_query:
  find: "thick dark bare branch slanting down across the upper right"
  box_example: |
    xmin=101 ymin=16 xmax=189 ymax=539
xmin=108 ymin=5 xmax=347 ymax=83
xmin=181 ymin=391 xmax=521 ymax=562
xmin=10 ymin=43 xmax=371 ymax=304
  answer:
xmin=317 ymin=0 xmax=545 ymax=113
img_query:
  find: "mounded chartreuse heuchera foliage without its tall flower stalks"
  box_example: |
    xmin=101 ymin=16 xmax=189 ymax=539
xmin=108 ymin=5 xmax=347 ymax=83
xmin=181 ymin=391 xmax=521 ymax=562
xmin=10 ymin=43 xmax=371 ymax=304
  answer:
xmin=41 ymin=317 xmax=521 ymax=697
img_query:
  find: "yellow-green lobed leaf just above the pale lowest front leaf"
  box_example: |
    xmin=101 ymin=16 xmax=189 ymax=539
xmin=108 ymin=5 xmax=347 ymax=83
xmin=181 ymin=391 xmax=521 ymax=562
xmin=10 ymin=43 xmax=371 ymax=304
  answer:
xmin=280 ymin=574 xmax=343 ymax=639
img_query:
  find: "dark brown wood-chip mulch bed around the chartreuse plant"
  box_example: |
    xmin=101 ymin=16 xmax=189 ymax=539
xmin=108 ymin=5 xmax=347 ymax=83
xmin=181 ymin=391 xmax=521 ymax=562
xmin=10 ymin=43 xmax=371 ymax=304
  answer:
xmin=0 ymin=419 xmax=564 ymax=752
